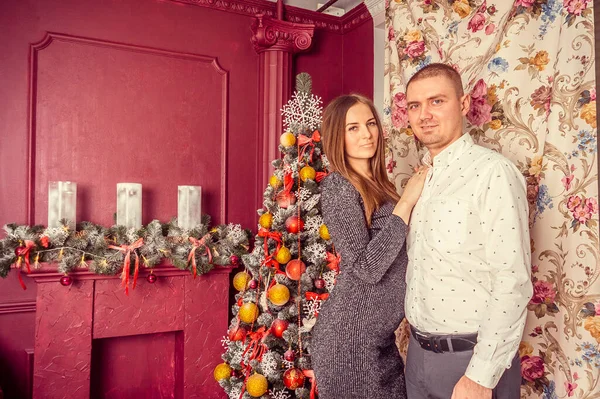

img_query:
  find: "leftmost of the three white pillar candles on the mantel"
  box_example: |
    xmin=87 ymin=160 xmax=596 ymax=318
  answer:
xmin=48 ymin=181 xmax=77 ymax=230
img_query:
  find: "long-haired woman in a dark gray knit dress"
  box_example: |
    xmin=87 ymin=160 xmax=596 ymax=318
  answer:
xmin=311 ymin=95 xmax=426 ymax=399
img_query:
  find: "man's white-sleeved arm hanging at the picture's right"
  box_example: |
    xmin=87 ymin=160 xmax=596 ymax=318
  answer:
xmin=465 ymin=159 xmax=533 ymax=388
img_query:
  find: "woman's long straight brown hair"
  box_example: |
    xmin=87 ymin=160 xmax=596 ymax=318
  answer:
xmin=321 ymin=94 xmax=400 ymax=226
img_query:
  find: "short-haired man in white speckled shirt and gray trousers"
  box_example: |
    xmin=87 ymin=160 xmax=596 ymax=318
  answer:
xmin=405 ymin=64 xmax=532 ymax=399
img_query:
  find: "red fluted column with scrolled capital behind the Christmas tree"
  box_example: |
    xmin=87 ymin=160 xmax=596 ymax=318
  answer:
xmin=252 ymin=0 xmax=315 ymax=206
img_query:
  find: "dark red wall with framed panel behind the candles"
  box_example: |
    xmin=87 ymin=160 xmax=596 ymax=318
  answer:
xmin=0 ymin=0 xmax=373 ymax=398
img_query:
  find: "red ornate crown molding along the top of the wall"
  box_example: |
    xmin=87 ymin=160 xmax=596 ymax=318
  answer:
xmin=169 ymin=0 xmax=370 ymax=34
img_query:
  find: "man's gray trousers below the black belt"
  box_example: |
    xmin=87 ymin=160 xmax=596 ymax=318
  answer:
xmin=405 ymin=334 xmax=521 ymax=399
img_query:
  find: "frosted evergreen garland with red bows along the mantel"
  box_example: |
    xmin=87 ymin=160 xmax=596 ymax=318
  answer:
xmin=0 ymin=215 xmax=250 ymax=290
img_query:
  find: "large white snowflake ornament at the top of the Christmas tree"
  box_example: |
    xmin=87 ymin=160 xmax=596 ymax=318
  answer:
xmin=281 ymin=92 xmax=323 ymax=131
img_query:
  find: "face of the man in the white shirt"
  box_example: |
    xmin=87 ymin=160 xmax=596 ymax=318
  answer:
xmin=406 ymin=76 xmax=471 ymax=157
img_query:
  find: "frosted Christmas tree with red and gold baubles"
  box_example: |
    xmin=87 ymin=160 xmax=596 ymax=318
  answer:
xmin=215 ymin=74 xmax=340 ymax=399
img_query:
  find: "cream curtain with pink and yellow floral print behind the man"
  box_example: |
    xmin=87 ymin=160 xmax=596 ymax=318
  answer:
xmin=384 ymin=0 xmax=600 ymax=399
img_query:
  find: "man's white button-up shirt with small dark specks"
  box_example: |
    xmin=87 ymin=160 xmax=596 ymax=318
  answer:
xmin=406 ymin=134 xmax=533 ymax=388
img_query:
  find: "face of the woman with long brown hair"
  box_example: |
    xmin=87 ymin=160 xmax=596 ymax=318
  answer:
xmin=344 ymin=103 xmax=379 ymax=165
